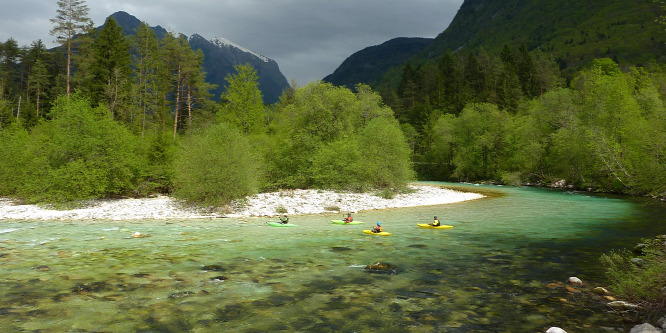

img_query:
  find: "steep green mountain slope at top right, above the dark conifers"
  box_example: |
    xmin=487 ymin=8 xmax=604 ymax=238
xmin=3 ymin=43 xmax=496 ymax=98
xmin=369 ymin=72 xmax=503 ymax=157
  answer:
xmin=419 ymin=0 xmax=666 ymax=67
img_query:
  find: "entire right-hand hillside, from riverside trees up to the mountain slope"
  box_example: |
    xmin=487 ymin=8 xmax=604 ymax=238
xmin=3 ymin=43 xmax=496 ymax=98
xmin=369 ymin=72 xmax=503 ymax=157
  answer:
xmin=366 ymin=0 xmax=666 ymax=197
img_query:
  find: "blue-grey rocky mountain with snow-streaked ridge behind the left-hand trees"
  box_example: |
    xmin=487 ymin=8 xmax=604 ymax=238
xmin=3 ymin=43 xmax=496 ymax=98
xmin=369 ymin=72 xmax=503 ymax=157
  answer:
xmin=110 ymin=11 xmax=289 ymax=104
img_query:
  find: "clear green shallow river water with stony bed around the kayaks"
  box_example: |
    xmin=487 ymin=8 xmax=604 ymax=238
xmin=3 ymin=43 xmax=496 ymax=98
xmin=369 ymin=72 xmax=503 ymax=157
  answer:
xmin=0 ymin=183 xmax=666 ymax=332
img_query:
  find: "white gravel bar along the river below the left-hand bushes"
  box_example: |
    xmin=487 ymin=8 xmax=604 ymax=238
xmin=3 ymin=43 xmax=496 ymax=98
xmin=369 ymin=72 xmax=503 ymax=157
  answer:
xmin=0 ymin=184 xmax=485 ymax=220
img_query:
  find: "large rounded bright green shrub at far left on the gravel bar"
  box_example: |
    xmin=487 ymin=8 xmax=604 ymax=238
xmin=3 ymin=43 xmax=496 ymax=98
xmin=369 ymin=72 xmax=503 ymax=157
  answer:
xmin=11 ymin=93 xmax=140 ymax=202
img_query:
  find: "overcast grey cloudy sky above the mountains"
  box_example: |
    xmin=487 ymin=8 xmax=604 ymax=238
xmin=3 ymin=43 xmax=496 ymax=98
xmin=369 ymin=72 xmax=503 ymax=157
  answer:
xmin=0 ymin=0 xmax=463 ymax=86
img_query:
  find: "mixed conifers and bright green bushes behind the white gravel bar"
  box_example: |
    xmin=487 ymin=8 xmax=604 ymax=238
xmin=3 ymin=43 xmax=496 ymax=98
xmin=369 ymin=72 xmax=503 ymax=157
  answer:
xmin=0 ymin=8 xmax=414 ymax=205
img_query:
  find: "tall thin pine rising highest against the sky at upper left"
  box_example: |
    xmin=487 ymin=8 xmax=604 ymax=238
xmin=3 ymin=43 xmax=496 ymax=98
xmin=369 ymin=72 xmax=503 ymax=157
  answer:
xmin=51 ymin=0 xmax=93 ymax=96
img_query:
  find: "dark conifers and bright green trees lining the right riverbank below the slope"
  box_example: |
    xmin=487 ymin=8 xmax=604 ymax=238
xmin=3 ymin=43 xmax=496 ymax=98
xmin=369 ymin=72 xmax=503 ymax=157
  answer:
xmin=382 ymin=45 xmax=666 ymax=197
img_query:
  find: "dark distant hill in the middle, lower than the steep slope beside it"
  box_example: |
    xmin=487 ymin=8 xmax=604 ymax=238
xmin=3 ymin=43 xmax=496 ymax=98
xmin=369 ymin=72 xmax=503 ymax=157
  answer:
xmin=323 ymin=37 xmax=433 ymax=89
